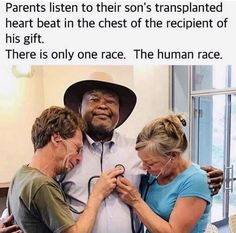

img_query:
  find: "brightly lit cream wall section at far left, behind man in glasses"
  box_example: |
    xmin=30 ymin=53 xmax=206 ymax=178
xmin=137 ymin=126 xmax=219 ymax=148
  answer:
xmin=0 ymin=67 xmax=44 ymax=183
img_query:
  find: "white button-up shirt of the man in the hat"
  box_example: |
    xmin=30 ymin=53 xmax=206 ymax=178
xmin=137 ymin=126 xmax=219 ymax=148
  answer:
xmin=62 ymin=132 xmax=144 ymax=233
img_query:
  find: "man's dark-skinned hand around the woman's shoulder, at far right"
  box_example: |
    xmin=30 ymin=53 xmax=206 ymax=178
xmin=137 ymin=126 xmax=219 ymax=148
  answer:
xmin=201 ymin=166 xmax=224 ymax=196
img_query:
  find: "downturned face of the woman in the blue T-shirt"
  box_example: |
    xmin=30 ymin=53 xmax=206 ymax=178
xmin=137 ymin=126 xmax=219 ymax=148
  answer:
xmin=138 ymin=147 xmax=170 ymax=176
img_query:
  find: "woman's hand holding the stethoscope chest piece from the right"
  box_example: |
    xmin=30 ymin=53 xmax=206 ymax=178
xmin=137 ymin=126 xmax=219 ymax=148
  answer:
xmin=116 ymin=176 xmax=141 ymax=206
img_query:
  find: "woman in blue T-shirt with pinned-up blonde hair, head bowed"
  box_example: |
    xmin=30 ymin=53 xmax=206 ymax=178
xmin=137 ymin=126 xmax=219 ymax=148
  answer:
xmin=117 ymin=114 xmax=211 ymax=233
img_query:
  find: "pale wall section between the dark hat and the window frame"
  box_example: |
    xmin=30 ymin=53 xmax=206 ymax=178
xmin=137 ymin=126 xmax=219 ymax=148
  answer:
xmin=131 ymin=66 xmax=169 ymax=137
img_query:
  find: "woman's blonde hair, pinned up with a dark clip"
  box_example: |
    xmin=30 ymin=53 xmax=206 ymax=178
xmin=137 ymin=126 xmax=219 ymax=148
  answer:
xmin=135 ymin=114 xmax=188 ymax=156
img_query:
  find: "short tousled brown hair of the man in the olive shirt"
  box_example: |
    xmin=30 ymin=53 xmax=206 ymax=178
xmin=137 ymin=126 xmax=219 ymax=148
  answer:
xmin=31 ymin=106 xmax=84 ymax=150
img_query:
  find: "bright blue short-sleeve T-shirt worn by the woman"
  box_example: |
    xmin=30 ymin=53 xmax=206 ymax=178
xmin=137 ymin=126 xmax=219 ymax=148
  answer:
xmin=144 ymin=164 xmax=212 ymax=233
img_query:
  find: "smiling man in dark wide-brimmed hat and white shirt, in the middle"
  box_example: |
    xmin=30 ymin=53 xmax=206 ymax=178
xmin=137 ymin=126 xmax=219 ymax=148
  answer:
xmin=61 ymin=73 xmax=223 ymax=233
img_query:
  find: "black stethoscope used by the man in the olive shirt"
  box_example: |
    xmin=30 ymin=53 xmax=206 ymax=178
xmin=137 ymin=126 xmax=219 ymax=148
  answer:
xmin=58 ymin=164 xmax=125 ymax=214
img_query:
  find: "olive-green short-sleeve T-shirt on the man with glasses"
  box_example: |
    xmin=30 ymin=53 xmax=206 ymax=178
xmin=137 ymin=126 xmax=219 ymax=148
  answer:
xmin=7 ymin=166 xmax=75 ymax=233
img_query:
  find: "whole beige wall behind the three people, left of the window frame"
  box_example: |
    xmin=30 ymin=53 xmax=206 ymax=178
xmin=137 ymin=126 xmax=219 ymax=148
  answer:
xmin=0 ymin=66 xmax=169 ymax=183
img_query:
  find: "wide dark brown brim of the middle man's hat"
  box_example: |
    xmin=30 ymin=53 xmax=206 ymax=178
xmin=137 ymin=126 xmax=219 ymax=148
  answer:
xmin=64 ymin=80 xmax=137 ymax=128
